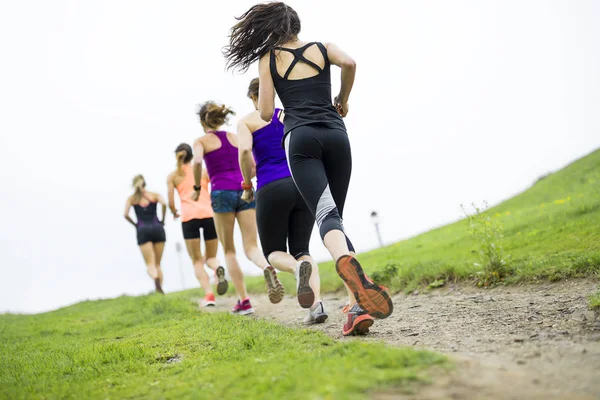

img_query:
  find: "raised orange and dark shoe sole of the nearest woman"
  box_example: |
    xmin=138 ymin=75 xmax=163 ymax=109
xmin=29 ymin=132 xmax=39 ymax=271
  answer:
xmin=335 ymin=257 xmax=394 ymax=319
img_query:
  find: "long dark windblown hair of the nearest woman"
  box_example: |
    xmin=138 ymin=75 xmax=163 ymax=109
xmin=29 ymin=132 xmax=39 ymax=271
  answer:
xmin=223 ymin=2 xmax=300 ymax=72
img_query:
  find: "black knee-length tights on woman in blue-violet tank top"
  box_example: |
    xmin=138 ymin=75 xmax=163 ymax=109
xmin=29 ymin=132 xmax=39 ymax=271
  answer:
xmin=256 ymin=177 xmax=315 ymax=258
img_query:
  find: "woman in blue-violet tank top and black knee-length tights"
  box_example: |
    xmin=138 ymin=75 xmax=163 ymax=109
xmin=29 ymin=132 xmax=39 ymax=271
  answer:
xmin=238 ymin=78 xmax=327 ymax=324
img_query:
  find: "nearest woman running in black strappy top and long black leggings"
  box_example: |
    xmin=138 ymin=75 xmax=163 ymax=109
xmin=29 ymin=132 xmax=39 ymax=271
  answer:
xmin=224 ymin=3 xmax=393 ymax=335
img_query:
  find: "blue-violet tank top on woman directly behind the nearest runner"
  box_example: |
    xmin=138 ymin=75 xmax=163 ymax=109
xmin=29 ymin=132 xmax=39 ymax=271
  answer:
xmin=252 ymin=108 xmax=291 ymax=190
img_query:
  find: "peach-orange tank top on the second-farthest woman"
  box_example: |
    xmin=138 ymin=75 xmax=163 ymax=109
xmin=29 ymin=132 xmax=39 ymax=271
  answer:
xmin=177 ymin=164 xmax=213 ymax=222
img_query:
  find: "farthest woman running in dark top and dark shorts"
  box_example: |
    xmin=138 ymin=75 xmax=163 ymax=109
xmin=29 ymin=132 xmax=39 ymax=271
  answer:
xmin=125 ymin=175 xmax=167 ymax=293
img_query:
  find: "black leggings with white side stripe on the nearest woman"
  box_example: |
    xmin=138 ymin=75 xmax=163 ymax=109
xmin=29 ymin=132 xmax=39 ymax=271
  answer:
xmin=284 ymin=125 xmax=354 ymax=251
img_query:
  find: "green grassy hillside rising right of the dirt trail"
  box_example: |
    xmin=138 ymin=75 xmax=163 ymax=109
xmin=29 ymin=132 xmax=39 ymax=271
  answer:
xmin=248 ymin=150 xmax=600 ymax=293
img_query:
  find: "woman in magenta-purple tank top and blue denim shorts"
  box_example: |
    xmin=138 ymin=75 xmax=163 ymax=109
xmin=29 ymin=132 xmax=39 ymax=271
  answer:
xmin=192 ymin=101 xmax=283 ymax=315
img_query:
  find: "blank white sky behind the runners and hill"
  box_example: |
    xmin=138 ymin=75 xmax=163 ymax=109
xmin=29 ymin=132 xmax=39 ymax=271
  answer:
xmin=0 ymin=0 xmax=600 ymax=312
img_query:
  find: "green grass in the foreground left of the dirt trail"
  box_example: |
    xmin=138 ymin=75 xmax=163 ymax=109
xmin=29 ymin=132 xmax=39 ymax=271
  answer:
xmin=0 ymin=292 xmax=446 ymax=399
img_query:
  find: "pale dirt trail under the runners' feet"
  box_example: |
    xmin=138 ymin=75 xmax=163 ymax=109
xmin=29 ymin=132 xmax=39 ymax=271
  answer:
xmin=199 ymin=280 xmax=600 ymax=400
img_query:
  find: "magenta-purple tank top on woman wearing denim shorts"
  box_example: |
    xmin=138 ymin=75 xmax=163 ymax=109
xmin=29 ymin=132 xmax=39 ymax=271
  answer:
xmin=204 ymin=131 xmax=243 ymax=190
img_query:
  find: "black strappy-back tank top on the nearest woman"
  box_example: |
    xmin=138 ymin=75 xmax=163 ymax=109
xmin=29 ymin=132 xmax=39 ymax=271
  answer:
xmin=269 ymin=42 xmax=346 ymax=136
